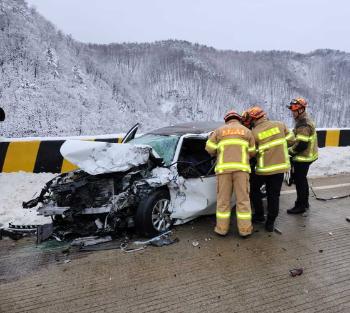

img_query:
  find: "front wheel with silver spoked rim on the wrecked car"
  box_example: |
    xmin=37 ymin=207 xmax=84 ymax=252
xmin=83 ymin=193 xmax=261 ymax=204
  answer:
xmin=135 ymin=190 xmax=173 ymax=237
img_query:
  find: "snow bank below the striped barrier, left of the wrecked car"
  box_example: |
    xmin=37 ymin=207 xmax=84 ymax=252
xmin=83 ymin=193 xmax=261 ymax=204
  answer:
xmin=0 ymin=172 xmax=54 ymax=227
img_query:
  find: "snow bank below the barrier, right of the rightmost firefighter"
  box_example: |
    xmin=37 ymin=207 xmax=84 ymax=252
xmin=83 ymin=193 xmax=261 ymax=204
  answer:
xmin=309 ymin=147 xmax=350 ymax=176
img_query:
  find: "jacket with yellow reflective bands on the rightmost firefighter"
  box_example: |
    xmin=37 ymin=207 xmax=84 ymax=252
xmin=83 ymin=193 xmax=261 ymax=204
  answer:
xmin=289 ymin=113 xmax=318 ymax=162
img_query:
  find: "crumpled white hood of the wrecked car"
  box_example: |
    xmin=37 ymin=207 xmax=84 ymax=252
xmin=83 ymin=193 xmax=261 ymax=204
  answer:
xmin=60 ymin=140 xmax=152 ymax=175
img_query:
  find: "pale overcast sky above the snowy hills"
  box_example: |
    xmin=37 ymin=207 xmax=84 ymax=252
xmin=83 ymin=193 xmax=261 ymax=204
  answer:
xmin=27 ymin=0 xmax=350 ymax=52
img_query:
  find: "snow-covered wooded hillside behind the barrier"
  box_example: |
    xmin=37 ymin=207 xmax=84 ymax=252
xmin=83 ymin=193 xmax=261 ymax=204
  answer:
xmin=0 ymin=0 xmax=350 ymax=137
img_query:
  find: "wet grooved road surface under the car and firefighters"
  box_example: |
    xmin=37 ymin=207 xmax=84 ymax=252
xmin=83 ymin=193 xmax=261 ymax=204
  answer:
xmin=0 ymin=176 xmax=350 ymax=313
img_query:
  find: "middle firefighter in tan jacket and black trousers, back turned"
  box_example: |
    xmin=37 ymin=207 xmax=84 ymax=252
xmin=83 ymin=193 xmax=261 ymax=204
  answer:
xmin=247 ymin=106 xmax=294 ymax=232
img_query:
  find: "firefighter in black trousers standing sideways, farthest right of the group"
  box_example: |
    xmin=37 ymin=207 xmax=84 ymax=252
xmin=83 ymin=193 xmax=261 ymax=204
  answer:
xmin=287 ymin=98 xmax=318 ymax=214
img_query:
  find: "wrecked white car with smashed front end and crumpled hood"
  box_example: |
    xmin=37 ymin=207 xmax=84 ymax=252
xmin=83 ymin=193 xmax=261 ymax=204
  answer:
xmin=23 ymin=123 xmax=221 ymax=236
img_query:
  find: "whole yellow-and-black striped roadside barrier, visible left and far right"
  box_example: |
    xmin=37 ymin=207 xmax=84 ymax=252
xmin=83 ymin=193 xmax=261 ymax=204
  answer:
xmin=0 ymin=129 xmax=350 ymax=173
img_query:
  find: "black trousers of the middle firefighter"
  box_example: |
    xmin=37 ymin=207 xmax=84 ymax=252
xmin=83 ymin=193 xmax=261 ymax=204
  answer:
xmin=251 ymin=173 xmax=284 ymax=222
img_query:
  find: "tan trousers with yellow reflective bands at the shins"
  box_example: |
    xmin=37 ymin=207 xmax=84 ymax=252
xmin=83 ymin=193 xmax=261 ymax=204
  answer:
xmin=215 ymin=171 xmax=253 ymax=236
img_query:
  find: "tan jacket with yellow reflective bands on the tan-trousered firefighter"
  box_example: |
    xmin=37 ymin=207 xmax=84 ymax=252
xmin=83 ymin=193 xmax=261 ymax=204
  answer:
xmin=205 ymin=120 xmax=256 ymax=174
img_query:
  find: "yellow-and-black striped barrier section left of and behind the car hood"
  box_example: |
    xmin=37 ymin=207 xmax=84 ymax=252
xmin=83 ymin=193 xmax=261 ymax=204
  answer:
xmin=0 ymin=138 xmax=122 ymax=173
